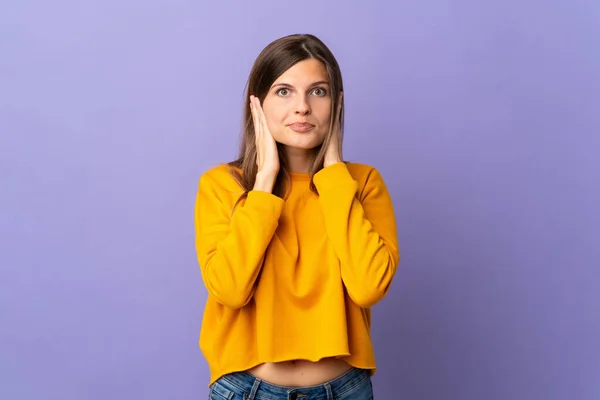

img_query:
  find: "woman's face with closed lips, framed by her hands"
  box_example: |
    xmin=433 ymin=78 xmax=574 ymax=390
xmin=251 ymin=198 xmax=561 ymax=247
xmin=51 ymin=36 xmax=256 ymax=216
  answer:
xmin=262 ymin=59 xmax=331 ymax=150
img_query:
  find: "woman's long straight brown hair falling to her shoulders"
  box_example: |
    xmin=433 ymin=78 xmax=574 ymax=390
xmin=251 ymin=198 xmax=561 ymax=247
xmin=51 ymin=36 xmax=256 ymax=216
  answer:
xmin=229 ymin=34 xmax=344 ymax=203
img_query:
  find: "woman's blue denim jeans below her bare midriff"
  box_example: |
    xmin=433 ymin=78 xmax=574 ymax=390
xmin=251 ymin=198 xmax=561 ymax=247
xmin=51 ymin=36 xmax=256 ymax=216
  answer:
xmin=209 ymin=368 xmax=373 ymax=400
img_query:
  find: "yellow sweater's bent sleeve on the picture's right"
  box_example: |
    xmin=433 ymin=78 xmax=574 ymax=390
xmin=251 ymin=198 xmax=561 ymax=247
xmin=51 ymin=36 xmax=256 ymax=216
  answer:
xmin=314 ymin=162 xmax=400 ymax=308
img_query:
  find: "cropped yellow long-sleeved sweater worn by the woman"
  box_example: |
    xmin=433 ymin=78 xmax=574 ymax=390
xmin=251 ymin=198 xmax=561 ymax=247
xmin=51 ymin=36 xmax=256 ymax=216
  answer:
xmin=195 ymin=163 xmax=399 ymax=384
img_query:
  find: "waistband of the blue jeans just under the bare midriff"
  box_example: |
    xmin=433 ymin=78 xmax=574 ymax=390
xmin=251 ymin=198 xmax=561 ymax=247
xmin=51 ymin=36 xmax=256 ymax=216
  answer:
xmin=222 ymin=367 xmax=370 ymax=400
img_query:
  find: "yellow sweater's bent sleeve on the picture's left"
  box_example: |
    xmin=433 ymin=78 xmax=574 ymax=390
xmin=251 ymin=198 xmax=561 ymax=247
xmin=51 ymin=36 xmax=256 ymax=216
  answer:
xmin=194 ymin=173 xmax=284 ymax=308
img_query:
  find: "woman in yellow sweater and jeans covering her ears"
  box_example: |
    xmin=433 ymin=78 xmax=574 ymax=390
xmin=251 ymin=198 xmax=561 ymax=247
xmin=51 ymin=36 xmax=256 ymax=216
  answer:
xmin=195 ymin=35 xmax=399 ymax=400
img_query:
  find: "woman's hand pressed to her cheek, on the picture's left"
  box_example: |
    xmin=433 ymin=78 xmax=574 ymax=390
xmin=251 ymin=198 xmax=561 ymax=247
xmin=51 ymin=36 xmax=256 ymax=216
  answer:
xmin=250 ymin=96 xmax=279 ymax=192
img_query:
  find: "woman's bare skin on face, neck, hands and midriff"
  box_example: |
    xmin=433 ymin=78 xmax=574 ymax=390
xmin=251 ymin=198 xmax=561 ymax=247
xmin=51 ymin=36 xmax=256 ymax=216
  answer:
xmin=248 ymin=59 xmax=351 ymax=387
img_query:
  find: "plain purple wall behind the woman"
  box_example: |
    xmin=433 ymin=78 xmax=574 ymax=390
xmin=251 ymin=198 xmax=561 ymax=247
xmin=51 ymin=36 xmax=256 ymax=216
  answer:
xmin=0 ymin=0 xmax=600 ymax=400
